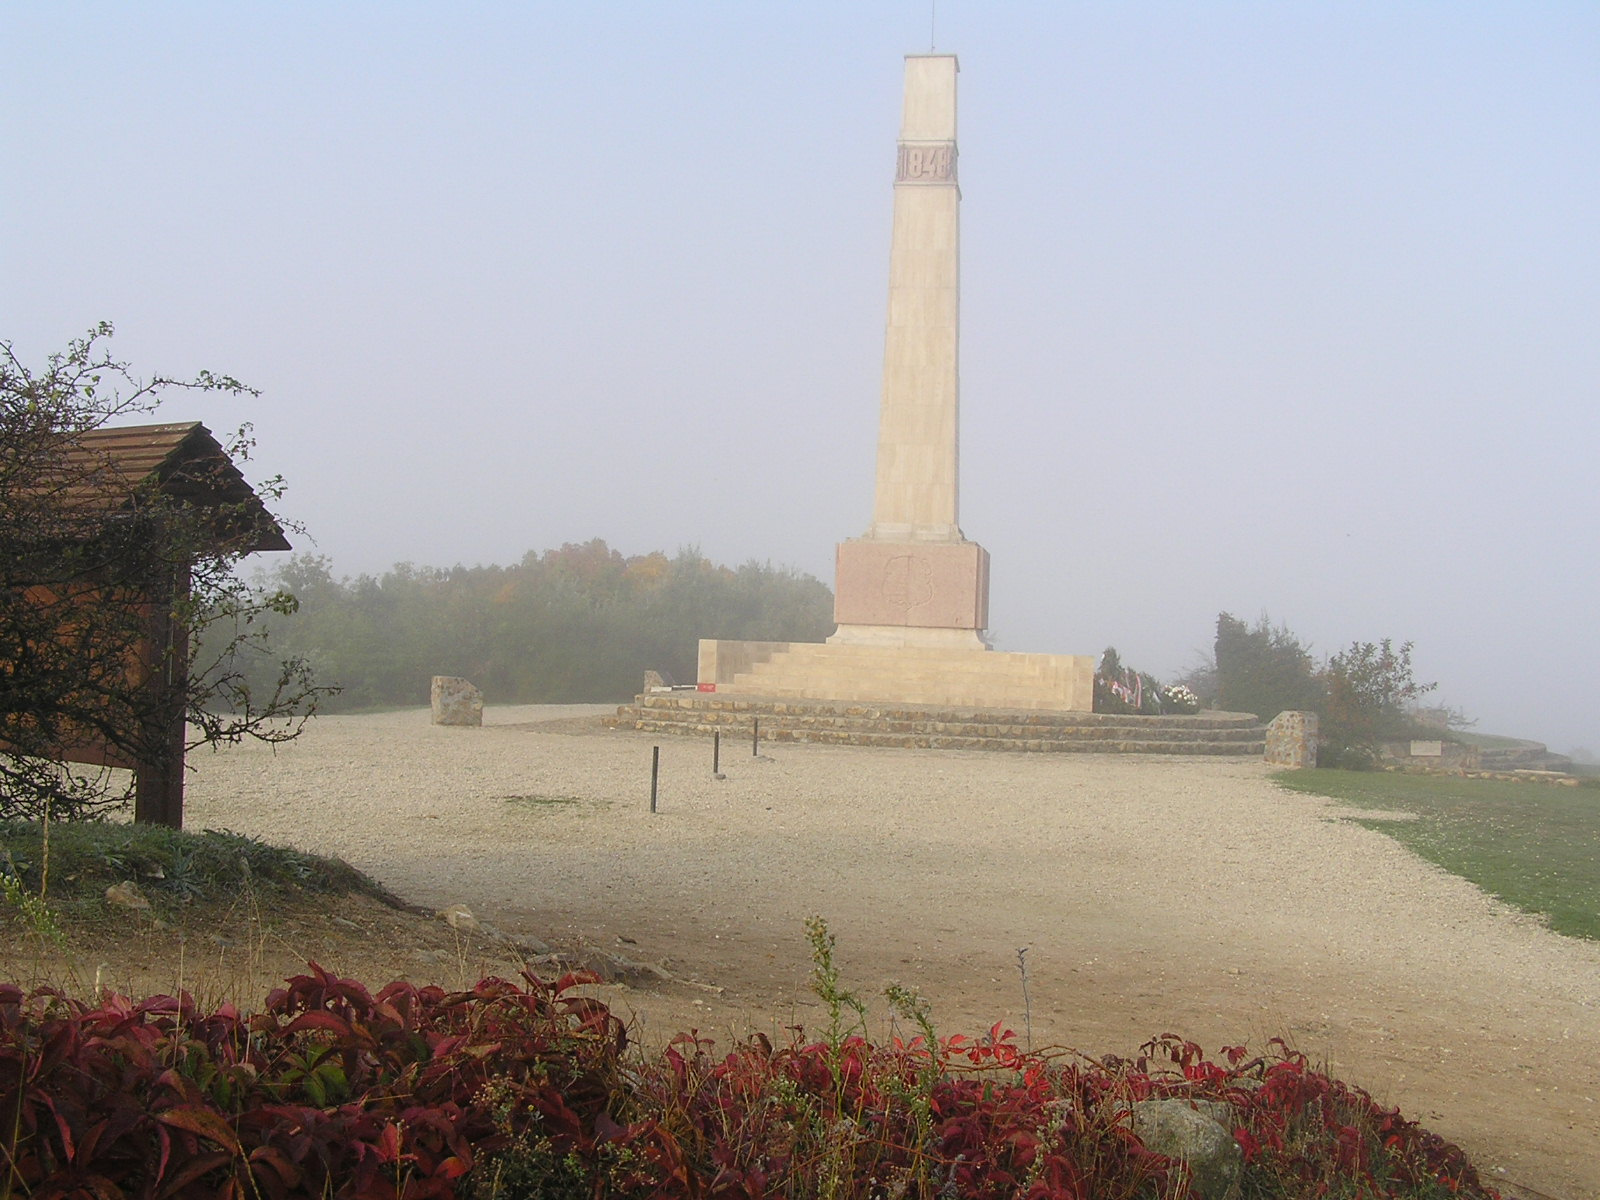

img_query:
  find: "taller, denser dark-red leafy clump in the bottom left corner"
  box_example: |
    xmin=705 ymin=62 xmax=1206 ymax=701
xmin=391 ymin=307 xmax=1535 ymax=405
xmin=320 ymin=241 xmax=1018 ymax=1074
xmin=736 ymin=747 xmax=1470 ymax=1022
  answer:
xmin=0 ymin=965 xmax=624 ymax=1200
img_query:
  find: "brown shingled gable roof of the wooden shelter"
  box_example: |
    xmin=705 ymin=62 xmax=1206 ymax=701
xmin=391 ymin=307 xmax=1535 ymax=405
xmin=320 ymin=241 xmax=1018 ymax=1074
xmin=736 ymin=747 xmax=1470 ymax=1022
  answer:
xmin=61 ymin=421 xmax=290 ymax=550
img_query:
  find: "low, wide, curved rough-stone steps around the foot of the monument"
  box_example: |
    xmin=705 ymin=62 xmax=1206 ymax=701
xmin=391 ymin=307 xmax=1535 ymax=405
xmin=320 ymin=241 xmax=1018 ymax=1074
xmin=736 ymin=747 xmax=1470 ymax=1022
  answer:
xmin=606 ymin=691 xmax=1266 ymax=758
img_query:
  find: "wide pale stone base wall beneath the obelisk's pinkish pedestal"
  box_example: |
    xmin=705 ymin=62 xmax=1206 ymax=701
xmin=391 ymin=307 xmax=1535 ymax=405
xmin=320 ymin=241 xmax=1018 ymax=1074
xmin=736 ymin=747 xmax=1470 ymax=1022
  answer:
xmin=699 ymin=630 xmax=1094 ymax=712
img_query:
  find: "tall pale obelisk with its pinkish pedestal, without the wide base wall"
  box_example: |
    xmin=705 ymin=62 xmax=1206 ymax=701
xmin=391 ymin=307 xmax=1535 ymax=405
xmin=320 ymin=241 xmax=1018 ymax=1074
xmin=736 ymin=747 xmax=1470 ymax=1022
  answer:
xmin=829 ymin=54 xmax=989 ymax=650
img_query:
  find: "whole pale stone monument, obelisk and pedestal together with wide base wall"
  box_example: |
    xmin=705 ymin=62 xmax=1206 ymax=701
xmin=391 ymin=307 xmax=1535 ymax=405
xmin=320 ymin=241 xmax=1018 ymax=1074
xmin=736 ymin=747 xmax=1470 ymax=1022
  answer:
xmin=684 ymin=54 xmax=1094 ymax=713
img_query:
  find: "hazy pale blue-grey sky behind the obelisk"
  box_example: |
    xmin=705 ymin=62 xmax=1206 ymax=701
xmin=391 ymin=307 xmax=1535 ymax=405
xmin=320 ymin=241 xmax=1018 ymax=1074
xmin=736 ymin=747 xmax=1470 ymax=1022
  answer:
xmin=0 ymin=0 xmax=1600 ymax=749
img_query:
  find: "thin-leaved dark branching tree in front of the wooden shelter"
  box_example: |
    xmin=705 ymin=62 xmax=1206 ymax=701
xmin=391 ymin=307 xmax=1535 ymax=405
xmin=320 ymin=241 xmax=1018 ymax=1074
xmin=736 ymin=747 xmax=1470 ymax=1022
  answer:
xmin=0 ymin=323 xmax=325 ymax=822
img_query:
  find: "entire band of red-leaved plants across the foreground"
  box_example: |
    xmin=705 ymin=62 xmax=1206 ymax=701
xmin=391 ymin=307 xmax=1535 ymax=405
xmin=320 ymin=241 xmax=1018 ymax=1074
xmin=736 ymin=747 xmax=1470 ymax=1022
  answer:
xmin=0 ymin=965 xmax=1496 ymax=1200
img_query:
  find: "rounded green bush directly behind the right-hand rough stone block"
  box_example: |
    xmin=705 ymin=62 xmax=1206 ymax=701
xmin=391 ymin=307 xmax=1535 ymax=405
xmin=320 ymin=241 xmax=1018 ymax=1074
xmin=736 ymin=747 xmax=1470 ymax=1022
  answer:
xmin=1318 ymin=637 xmax=1437 ymax=766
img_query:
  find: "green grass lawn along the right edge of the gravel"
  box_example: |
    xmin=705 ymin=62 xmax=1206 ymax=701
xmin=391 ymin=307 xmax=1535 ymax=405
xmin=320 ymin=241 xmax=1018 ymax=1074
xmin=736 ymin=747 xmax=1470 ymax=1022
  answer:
xmin=1274 ymin=770 xmax=1600 ymax=941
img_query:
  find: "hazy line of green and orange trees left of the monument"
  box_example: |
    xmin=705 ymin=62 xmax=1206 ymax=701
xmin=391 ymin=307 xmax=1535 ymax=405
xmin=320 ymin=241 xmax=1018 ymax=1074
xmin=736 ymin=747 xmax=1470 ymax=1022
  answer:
xmin=236 ymin=538 xmax=834 ymax=710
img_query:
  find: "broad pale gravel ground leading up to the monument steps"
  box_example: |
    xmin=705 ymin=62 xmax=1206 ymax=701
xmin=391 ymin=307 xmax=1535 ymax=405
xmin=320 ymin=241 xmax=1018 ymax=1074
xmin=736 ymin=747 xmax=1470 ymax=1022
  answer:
xmin=187 ymin=707 xmax=1600 ymax=1200
